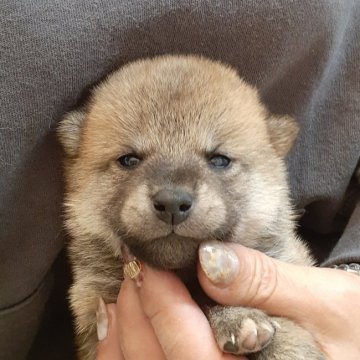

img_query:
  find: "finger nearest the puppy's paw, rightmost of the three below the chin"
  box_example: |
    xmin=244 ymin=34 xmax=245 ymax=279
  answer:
xmin=139 ymin=267 xmax=241 ymax=360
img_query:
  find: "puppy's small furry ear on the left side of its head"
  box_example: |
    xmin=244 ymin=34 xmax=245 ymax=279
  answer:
xmin=57 ymin=109 xmax=86 ymax=157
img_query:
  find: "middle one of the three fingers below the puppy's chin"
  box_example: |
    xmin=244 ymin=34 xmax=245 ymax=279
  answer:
xmin=117 ymin=279 xmax=165 ymax=360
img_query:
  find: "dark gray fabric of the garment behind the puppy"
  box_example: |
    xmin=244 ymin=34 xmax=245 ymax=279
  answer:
xmin=0 ymin=0 xmax=360 ymax=360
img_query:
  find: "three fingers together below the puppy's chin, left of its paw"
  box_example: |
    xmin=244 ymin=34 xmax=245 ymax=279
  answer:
xmin=97 ymin=266 xmax=244 ymax=360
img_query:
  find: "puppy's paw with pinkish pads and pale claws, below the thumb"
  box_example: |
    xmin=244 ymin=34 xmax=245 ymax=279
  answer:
xmin=208 ymin=306 xmax=275 ymax=355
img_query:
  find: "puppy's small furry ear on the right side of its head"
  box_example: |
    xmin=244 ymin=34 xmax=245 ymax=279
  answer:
xmin=267 ymin=115 xmax=299 ymax=157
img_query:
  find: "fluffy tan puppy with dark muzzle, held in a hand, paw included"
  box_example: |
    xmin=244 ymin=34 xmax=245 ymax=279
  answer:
xmin=59 ymin=56 xmax=324 ymax=360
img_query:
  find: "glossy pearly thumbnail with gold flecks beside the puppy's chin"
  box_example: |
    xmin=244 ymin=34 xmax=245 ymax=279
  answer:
xmin=199 ymin=241 xmax=239 ymax=285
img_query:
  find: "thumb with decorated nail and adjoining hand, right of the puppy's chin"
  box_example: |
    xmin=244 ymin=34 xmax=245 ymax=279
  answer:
xmin=198 ymin=242 xmax=360 ymax=360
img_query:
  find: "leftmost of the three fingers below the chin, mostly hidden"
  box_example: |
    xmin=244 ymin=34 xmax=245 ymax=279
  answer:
xmin=96 ymin=304 xmax=125 ymax=360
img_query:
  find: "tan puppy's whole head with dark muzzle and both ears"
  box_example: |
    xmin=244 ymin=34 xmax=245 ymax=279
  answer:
xmin=59 ymin=57 xmax=296 ymax=269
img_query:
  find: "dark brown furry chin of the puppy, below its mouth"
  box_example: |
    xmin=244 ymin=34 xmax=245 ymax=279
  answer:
xmin=124 ymin=234 xmax=204 ymax=270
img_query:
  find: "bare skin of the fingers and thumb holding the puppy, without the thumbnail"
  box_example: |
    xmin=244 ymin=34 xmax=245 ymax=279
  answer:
xmin=98 ymin=244 xmax=360 ymax=360
